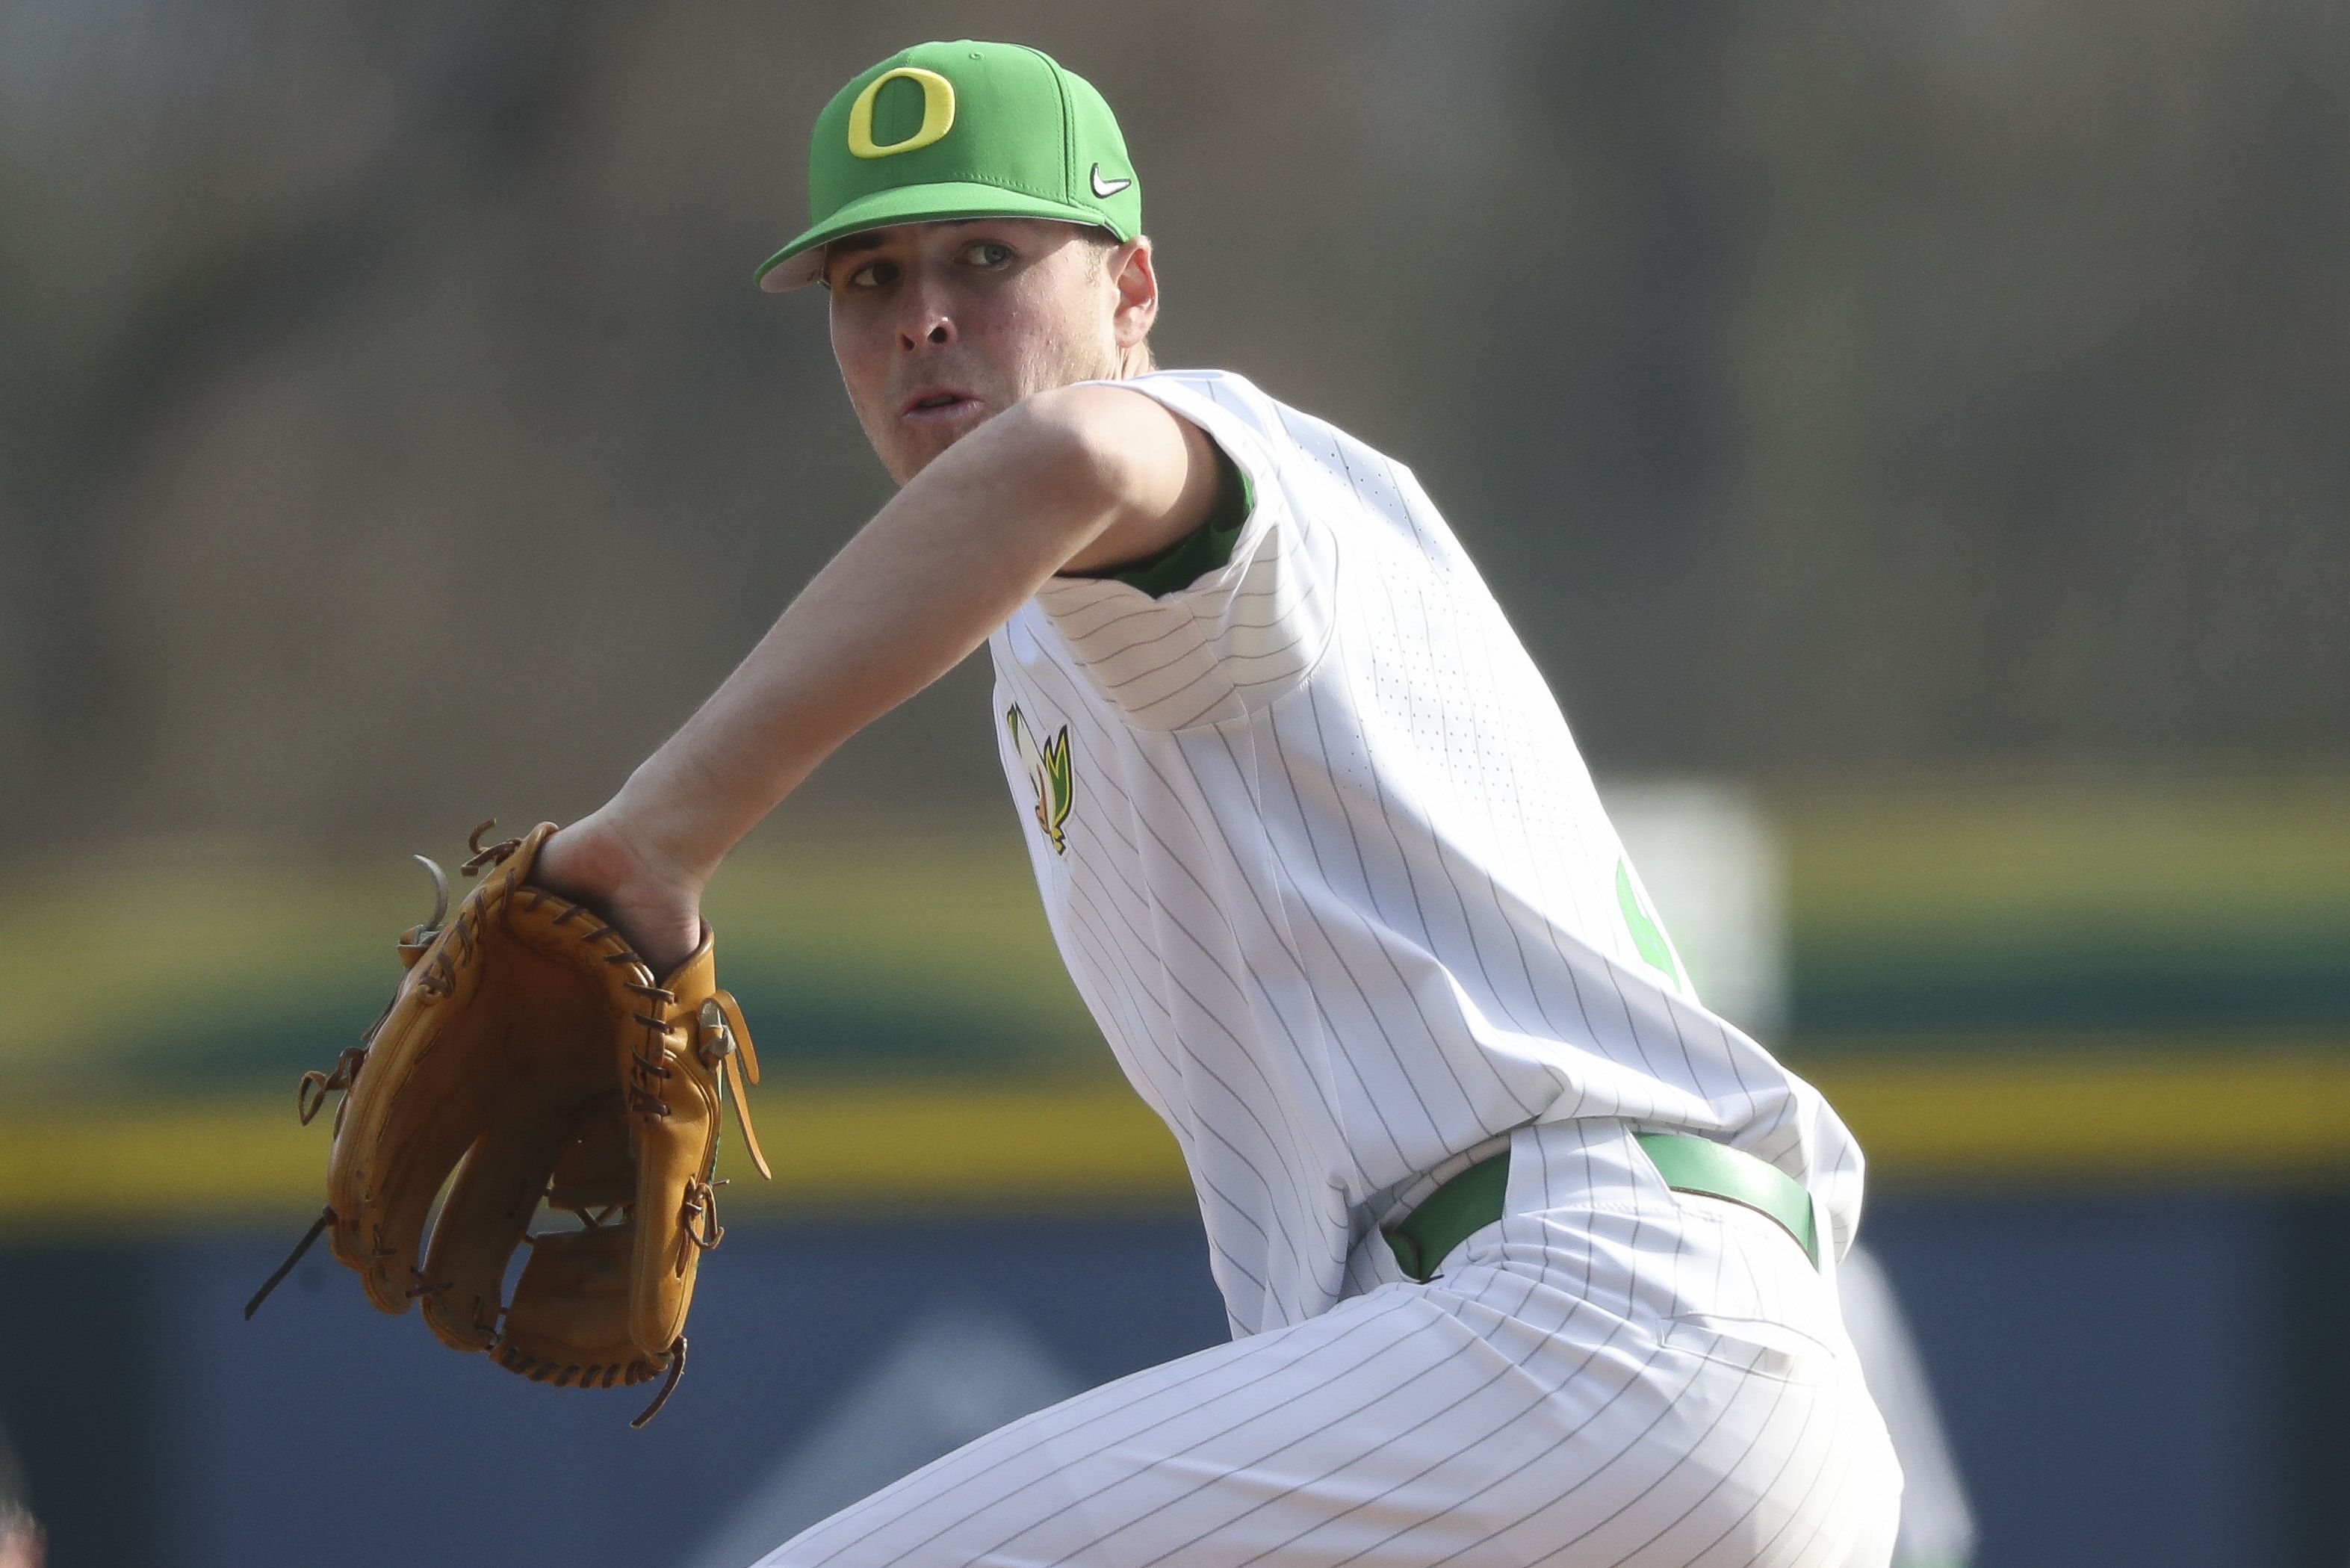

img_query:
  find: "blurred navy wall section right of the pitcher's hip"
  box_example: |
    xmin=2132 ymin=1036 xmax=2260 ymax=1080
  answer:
xmin=1864 ymin=1194 xmax=2287 ymax=1568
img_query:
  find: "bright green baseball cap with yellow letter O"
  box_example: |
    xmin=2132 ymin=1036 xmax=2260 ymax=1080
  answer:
xmin=757 ymin=37 xmax=1142 ymax=294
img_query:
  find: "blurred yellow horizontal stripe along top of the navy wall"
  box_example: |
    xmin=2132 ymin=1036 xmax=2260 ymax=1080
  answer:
xmin=13 ymin=1049 xmax=2350 ymax=1230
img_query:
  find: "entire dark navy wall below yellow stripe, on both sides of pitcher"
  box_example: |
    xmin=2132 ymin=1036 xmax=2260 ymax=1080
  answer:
xmin=0 ymin=1194 xmax=2350 ymax=1568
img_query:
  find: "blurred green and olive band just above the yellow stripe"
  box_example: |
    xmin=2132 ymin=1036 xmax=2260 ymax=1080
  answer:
xmin=0 ymin=781 xmax=2350 ymax=1109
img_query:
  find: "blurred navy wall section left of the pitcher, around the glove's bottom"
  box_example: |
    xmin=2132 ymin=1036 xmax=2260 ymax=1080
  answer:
xmin=154 ymin=1222 xmax=1224 ymax=1568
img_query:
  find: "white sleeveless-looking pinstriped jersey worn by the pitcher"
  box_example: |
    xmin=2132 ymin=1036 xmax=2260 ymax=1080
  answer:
xmin=989 ymin=371 xmax=1861 ymax=1333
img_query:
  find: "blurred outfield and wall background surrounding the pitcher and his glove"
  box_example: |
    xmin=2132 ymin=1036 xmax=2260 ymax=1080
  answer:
xmin=0 ymin=0 xmax=2350 ymax=1568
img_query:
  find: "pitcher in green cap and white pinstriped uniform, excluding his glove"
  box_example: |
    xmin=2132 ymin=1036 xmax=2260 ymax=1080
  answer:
xmin=531 ymin=40 xmax=1901 ymax=1568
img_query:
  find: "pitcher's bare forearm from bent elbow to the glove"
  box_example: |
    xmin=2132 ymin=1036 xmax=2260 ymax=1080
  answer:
xmin=607 ymin=394 xmax=1128 ymax=886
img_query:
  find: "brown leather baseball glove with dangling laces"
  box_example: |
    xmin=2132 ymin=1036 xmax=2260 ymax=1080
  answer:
xmin=244 ymin=822 xmax=771 ymax=1427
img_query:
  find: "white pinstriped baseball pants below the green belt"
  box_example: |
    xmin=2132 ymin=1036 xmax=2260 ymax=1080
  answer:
xmin=759 ymin=1124 xmax=1901 ymax=1568
